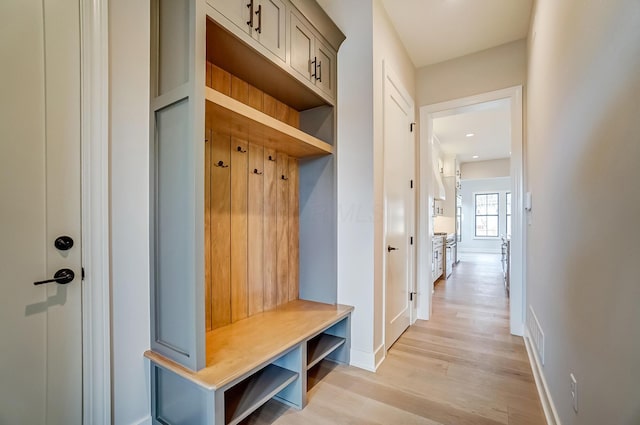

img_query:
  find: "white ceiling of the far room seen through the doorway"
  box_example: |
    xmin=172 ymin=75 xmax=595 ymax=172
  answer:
xmin=433 ymin=99 xmax=511 ymax=162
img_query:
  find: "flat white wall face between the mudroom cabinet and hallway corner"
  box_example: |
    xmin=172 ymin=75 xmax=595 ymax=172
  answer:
xmin=318 ymin=0 xmax=375 ymax=369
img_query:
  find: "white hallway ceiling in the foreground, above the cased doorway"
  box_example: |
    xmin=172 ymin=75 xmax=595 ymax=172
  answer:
xmin=382 ymin=0 xmax=533 ymax=68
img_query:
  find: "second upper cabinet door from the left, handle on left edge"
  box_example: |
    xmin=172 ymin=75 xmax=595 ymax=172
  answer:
xmin=254 ymin=0 xmax=287 ymax=61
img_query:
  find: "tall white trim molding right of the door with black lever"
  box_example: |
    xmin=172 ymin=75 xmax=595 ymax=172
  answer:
xmin=79 ymin=0 xmax=111 ymax=425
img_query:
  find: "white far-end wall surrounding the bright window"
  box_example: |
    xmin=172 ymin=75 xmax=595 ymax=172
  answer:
xmin=458 ymin=177 xmax=511 ymax=253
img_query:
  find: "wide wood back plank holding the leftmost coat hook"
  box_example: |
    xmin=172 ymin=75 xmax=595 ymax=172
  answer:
xmin=210 ymin=131 xmax=231 ymax=329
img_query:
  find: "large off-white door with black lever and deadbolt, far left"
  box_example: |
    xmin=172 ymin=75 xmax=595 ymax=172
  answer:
xmin=0 ymin=0 xmax=82 ymax=425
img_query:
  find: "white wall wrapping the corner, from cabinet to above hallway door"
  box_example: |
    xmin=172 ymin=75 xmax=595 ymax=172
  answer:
xmin=318 ymin=0 xmax=415 ymax=370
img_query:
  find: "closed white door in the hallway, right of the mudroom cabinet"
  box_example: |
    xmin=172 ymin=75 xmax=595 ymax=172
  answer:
xmin=383 ymin=64 xmax=415 ymax=350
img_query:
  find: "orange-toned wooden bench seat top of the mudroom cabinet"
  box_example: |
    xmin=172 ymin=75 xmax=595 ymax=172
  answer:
xmin=144 ymin=300 xmax=353 ymax=390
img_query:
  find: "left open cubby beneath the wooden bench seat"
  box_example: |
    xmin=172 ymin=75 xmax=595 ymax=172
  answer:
xmin=224 ymin=364 xmax=299 ymax=425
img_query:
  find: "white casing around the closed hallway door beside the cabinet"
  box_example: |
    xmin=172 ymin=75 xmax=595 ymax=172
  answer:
xmin=376 ymin=60 xmax=419 ymax=356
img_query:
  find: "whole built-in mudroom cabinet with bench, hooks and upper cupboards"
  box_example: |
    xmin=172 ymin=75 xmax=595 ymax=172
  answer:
xmin=145 ymin=0 xmax=353 ymax=425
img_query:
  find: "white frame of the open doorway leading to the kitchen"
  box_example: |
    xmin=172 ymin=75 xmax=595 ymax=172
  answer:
xmin=417 ymin=85 xmax=526 ymax=336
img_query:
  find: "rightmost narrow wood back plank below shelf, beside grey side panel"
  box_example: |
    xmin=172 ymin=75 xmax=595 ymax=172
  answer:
xmin=289 ymin=158 xmax=300 ymax=301
